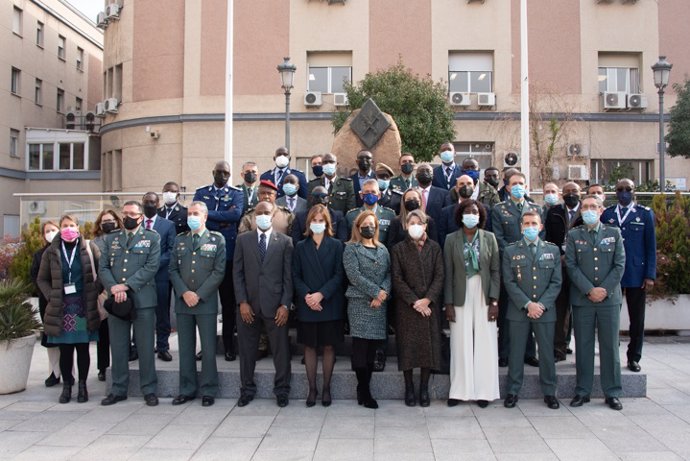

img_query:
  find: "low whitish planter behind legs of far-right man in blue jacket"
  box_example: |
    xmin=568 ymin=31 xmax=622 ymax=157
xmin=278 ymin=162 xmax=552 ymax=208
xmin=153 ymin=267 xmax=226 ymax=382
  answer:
xmin=621 ymin=295 xmax=690 ymax=333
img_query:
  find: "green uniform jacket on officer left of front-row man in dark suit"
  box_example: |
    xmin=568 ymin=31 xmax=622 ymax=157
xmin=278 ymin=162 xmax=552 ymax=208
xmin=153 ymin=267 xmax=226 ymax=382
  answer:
xmin=170 ymin=229 xmax=225 ymax=314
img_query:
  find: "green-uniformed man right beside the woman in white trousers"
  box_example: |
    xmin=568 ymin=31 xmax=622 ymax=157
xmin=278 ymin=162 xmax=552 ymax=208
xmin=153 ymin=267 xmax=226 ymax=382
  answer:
xmin=503 ymin=211 xmax=562 ymax=410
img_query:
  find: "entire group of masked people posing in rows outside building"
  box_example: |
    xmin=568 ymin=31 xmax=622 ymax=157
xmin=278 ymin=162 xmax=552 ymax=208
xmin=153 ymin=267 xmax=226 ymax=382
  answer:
xmin=34 ymin=143 xmax=656 ymax=410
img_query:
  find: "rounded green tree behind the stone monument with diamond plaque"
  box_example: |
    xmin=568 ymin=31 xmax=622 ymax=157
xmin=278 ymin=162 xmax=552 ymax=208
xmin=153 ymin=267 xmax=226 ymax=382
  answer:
xmin=333 ymin=61 xmax=455 ymax=161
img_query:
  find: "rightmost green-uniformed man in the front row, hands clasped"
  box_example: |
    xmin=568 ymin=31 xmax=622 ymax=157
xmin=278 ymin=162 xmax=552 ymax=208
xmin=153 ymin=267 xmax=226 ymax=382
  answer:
xmin=565 ymin=195 xmax=625 ymax=410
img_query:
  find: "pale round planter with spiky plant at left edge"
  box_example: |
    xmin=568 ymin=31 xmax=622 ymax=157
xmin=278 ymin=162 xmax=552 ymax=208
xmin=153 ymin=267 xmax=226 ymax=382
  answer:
xmin=0 ymin=333 xmax=36 ymax=394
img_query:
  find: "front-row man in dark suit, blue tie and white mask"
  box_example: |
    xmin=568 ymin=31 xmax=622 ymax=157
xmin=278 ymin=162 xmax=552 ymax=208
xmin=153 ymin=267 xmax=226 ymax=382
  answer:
xmin=233 ymin=202 xmax=293 ymax=407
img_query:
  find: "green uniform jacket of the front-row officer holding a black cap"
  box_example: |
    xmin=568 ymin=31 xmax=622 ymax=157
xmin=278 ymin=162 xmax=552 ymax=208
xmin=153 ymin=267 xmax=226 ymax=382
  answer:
xmin=98 ymin=225 xmax=161 ymax=309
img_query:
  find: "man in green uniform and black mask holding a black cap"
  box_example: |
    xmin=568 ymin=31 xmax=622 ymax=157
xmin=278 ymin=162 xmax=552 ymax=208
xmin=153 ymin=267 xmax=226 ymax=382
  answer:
xmin=98 ymin=201 xmax=161 ymax=406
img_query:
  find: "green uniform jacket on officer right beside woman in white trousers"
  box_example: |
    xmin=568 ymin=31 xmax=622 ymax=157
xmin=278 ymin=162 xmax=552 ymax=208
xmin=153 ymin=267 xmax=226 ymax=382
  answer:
xmin=503 ymin=238 xmax=562 ymax=322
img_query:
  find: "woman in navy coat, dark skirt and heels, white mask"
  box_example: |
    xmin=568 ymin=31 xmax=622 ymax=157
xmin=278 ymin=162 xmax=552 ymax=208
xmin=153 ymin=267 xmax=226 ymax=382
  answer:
xmin=292 ymin=205 xmax=345 ymax=407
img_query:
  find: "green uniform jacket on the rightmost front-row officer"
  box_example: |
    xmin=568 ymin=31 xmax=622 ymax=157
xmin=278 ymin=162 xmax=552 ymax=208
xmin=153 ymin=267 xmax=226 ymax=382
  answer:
xmin=565 ymin=223 xmax=625 ymax=307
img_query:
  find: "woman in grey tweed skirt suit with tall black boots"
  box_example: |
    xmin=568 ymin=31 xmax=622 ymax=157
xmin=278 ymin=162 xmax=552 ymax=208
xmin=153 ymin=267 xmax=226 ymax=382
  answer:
xmin=343 ymin=211 xmax=391 ymax=408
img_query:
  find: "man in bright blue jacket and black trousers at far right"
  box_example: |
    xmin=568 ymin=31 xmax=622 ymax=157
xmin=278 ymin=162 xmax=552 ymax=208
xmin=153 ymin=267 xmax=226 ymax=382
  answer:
xmin=601 ymin=178 xmax=656 ymax=372
